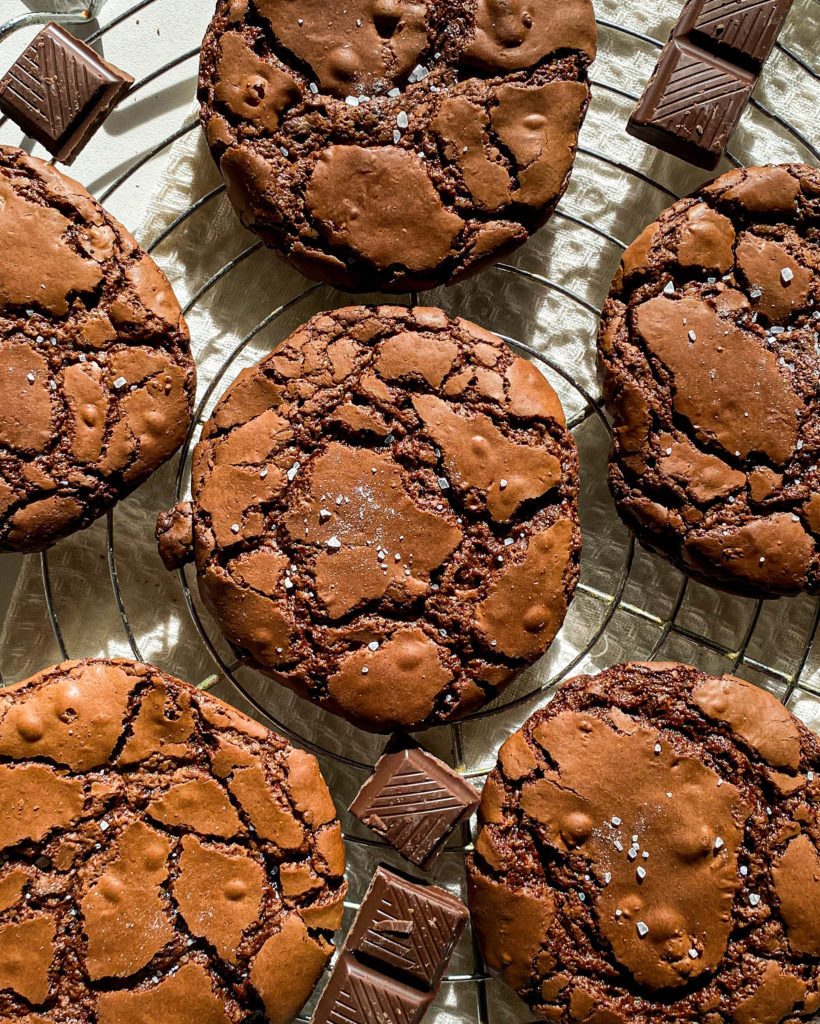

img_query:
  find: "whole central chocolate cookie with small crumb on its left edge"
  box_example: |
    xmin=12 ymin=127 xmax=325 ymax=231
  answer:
xmin=158 ymin=306 xmax=580 ymax=732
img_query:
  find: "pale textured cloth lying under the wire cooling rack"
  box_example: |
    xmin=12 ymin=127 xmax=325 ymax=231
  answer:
xmin=0 ymin=0 xmax=820 ymax=1024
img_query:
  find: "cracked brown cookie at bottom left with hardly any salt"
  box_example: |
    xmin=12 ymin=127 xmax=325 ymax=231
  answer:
xmin=0 ymin=659 xmax=345 ymax=1024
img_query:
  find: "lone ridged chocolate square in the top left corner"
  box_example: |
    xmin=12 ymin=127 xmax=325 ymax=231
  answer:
xmin=0 ymin=22 xmax=134 ymax=164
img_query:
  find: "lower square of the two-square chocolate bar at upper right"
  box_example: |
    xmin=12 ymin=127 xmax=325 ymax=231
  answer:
xmin=627 ymin=38 xmax=754 ymax=170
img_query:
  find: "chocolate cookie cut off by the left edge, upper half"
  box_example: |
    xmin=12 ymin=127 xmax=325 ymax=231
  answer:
xmin=0 ymin=146 xmax=196 ymax=551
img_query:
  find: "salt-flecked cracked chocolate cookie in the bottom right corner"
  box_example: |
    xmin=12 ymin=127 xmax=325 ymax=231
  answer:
xmin=468 ymin=664 xmax=820 ymax=1024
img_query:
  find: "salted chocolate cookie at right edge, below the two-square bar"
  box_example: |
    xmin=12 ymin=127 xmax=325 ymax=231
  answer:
xmin=599 ymin=164 xmax=820 ymax=597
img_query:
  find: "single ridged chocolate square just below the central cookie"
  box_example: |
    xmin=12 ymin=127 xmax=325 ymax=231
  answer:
xmin=350 ymin=746 xmax=480 ymax=870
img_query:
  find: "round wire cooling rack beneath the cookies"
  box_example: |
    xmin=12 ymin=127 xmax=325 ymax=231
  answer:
xmin=0 ymin=0 xmax=820 ymax=1024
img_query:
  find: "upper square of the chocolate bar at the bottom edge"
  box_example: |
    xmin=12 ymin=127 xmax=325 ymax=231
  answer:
xmin=345 ymin=867 xmax=469 ymax=990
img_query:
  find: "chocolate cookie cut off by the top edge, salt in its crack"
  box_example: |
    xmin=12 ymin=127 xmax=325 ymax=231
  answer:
xmin=199 ymin=0 xmax=596 ymax=292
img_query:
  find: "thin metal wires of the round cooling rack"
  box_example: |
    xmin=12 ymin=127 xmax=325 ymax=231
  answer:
xmin=0 ymin=0 xmax=820 ymax=1024
